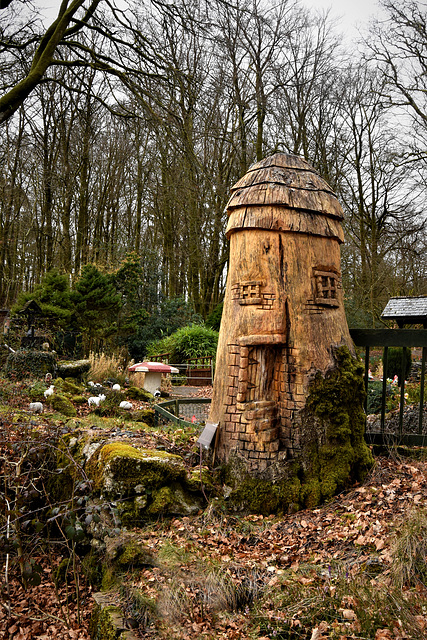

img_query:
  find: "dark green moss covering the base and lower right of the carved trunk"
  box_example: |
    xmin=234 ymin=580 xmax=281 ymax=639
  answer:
xmin=222 ymin=347 xmax=373 ymax=514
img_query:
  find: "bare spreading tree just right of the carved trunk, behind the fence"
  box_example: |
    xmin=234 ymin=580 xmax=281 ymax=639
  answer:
xmin=339 ymin=66 xmax=425 ymax=323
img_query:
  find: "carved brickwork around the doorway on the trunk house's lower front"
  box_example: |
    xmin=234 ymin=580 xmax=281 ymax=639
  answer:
xmin=223 ymin=344 xmax=305 ymax=471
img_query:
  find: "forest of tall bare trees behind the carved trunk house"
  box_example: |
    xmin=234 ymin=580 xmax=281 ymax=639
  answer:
xmin=0 ymin=0 xmax=427 ymax=357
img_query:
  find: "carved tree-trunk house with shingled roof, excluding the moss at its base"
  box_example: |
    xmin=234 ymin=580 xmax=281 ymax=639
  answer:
xmin=209 ymin=153 xmax=362 ymax=477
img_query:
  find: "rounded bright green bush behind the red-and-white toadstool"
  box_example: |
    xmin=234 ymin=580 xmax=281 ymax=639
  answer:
xmin=148 ymin=324 xmax=218 ymax=364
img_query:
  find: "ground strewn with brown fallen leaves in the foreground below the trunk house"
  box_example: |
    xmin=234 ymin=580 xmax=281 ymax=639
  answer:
xmin=0 ymin=398 xmax=427 ymax=640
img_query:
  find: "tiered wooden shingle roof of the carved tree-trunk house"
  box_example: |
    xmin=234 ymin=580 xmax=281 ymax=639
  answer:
xmin=226 ymin=153 xmax=344 ymax=242
